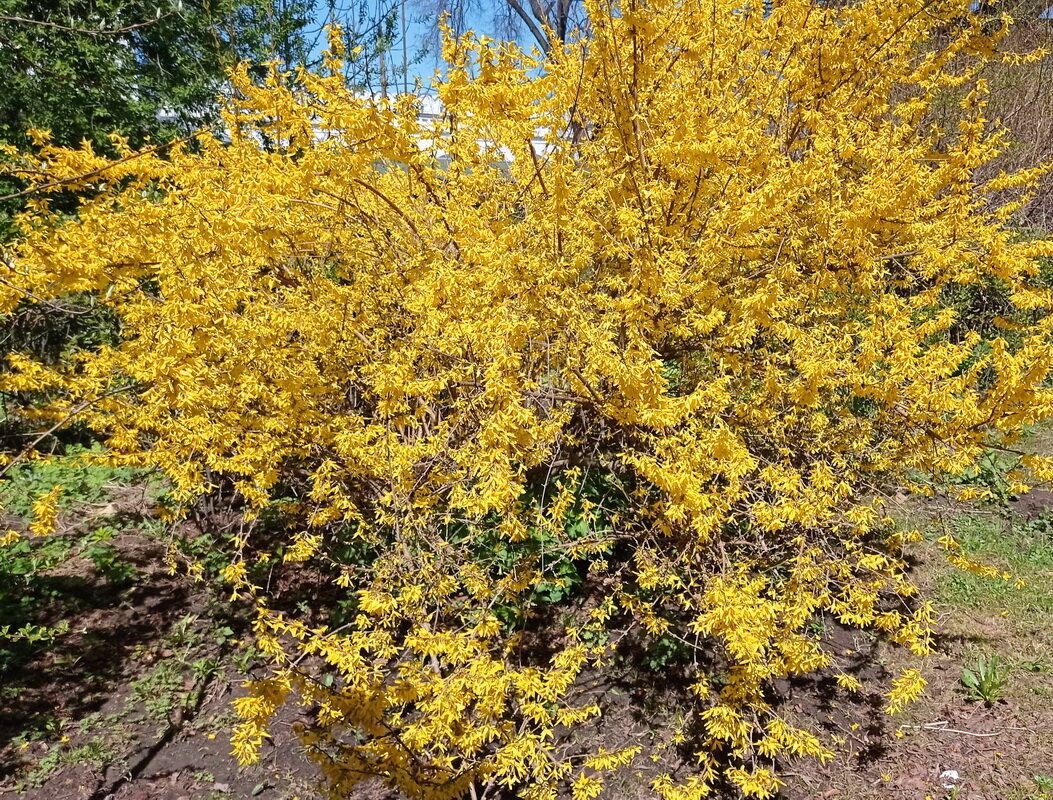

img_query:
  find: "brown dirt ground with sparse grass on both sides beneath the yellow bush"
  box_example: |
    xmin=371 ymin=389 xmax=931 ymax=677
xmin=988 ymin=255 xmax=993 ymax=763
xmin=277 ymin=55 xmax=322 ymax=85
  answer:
xmin=0 ymin=484 xmax=1053 ymax=800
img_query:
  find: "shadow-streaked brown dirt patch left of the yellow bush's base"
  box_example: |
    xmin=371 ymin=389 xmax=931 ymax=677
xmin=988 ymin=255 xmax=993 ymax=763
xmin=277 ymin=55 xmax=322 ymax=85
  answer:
xmin=0 ymin=489 xmax=324 ymax=800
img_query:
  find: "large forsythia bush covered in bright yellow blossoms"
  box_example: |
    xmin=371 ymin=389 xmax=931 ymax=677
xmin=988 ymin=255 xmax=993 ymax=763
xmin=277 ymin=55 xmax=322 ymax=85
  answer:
xmin=0 ymin=0 xmax=1053 ymax=800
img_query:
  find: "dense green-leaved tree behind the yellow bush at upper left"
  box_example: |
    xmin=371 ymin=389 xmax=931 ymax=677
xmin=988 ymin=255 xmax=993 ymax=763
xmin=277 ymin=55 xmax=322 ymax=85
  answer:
xmin=0 ymin=0 xmax=310 ymax=232
